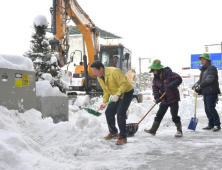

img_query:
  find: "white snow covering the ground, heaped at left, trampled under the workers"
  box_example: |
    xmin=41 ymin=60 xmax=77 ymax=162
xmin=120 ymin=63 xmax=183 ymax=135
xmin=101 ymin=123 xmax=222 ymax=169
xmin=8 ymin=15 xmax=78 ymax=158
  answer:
xmin=0 ymin=96 xmax=222 ymax=170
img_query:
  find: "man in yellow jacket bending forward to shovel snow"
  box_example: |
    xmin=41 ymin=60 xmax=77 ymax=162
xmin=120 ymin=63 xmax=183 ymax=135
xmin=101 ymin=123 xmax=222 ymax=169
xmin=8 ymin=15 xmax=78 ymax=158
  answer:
xmin=91 ymin=61 xmax=134 ymax=145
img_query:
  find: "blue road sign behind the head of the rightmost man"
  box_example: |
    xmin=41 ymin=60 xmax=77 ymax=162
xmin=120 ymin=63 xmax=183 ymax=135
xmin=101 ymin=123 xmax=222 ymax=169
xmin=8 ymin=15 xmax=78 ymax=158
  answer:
xmin=191 ymin=53 xmax=221 ymax=70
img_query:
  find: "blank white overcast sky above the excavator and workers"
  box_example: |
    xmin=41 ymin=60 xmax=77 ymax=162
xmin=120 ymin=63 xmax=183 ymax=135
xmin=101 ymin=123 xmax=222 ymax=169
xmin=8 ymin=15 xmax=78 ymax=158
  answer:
xmin=0 ymin=0 xmax=222 ymax=72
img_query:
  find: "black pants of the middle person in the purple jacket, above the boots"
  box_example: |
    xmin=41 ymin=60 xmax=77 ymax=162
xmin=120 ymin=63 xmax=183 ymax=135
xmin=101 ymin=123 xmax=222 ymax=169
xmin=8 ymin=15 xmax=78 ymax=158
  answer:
xmin=154 ymin=102 xmax=180 ymax=123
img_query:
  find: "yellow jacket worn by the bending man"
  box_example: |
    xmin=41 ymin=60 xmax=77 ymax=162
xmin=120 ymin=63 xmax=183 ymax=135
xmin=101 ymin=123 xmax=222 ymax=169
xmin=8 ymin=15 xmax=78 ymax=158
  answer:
xmin=97 ymin=67 xmax=133 ymax=103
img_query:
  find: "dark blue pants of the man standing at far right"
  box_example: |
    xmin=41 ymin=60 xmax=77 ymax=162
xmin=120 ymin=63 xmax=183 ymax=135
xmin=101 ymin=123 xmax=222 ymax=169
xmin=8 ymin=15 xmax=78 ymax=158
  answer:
xmin=204 ymin=94 xmax=220 ymax=127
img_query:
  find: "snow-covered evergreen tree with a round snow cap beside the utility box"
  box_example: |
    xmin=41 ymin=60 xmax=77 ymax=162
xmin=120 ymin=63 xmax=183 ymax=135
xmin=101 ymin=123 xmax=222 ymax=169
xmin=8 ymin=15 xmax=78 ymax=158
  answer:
xmin=24 ymin=15 xmax=67 ymax=93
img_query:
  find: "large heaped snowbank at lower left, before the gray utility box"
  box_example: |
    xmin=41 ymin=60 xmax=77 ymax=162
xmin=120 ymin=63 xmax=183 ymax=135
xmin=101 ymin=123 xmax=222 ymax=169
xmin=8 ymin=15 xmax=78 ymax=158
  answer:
xmin=0 ymin=106 xmax=110 ymax=169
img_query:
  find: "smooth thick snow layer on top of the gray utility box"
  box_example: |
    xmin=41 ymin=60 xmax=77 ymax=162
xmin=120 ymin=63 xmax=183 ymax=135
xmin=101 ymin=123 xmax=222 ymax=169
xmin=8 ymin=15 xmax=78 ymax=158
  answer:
xmin=0 ymin=54 xmax=34 ymax=71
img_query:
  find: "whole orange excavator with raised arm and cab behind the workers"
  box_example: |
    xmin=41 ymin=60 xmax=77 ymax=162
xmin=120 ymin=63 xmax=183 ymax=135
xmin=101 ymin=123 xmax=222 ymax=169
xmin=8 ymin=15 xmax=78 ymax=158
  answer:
xmin=50 ymin=0 xmax=142 ymax=102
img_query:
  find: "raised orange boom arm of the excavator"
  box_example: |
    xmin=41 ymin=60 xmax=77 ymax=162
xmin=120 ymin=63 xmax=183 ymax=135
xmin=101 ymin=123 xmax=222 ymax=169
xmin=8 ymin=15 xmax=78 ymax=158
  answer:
xmin=50 ymin=0 xmax=99 ymax=77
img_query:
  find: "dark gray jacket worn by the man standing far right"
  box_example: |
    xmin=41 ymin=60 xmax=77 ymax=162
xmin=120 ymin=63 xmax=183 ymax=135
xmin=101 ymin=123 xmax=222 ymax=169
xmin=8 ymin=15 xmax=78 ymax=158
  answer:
xmin=197 ymin=61 xmax=220 ymax=95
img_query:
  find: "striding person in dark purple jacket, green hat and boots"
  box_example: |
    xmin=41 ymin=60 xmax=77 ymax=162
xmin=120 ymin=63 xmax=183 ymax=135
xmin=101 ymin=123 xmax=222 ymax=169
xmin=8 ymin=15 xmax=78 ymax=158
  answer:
xmin=144 ymin=59 xmax=183 ymax=137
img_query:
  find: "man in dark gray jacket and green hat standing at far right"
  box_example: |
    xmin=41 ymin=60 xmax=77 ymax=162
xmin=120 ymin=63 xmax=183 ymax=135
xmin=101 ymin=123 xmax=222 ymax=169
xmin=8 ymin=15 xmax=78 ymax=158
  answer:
xmin=193 ymin=53 xmax=221 ymax=132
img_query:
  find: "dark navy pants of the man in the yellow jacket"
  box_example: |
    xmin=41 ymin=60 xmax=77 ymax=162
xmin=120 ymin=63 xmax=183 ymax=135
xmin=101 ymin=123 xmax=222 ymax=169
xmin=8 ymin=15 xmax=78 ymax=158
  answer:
xmin=105 ymin=90 xmax=134 ymax=138
